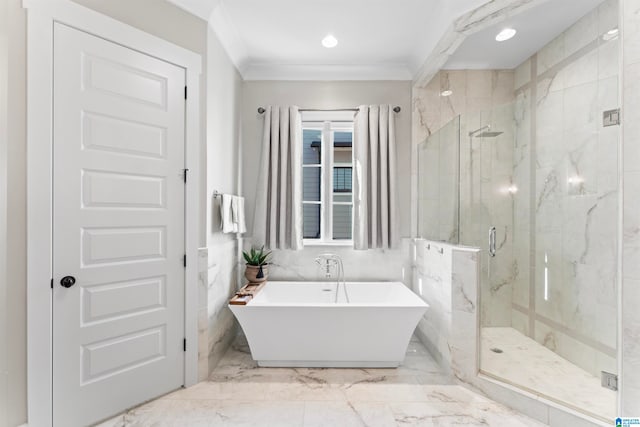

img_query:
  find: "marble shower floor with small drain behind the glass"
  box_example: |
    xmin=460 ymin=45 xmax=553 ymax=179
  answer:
xmin=480 ymin=327 xmax=616 ymax=422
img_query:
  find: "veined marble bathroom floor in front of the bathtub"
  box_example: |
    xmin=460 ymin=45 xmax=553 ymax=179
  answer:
xmin=100 ymin=337 xmax=542 ymax=427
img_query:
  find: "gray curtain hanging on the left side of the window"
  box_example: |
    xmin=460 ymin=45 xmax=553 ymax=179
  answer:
xmin=253 ymin=106 xmax=302 ymax=250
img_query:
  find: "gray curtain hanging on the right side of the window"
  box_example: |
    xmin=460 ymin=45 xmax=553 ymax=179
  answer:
xmin=353 ymin=105 xmax=398 ymax=249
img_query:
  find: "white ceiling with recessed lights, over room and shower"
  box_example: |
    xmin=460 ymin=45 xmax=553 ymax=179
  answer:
xmin=169 ymin=0 xmax=602 ymax=80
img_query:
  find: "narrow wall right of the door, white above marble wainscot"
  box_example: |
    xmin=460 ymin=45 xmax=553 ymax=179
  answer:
xmin=205 ymin=28 xmax=242 ymax=371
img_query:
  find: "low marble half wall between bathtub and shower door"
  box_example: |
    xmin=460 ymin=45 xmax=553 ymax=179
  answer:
xmin=410 ymin=239 xmax=480 ymax=382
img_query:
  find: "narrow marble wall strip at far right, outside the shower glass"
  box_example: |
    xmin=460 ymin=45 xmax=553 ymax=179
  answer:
xmin=620 ymin=0 xmax=640 ymax=417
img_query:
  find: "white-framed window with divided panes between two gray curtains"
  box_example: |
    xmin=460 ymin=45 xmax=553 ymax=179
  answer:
xmin=302 ymin=115 xmax=353 ymax=244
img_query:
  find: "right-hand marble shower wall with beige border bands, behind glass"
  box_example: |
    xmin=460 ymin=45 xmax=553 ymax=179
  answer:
xmin=512 ymin=0 xmax=619 ymax=375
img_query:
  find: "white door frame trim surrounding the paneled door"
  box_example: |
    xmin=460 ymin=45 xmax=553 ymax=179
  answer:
xmin=22 ymin=0 xmax=202 ymax=426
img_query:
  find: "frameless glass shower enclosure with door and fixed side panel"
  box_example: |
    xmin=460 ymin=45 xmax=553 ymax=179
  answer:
xmin=418 ymin=97 xmax=618 ymax=421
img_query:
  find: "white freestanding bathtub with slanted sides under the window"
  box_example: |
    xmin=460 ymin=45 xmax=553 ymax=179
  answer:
xmin=229 ymin=282 xmax=428 ymax=368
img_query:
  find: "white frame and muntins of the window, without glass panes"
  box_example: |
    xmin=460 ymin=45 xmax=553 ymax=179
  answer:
xmin=302 ymin=112 xmax=354 ymax=246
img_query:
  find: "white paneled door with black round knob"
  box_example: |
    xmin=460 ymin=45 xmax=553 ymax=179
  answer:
xmin=52 ymin=24 xmax=185 ymax=427
